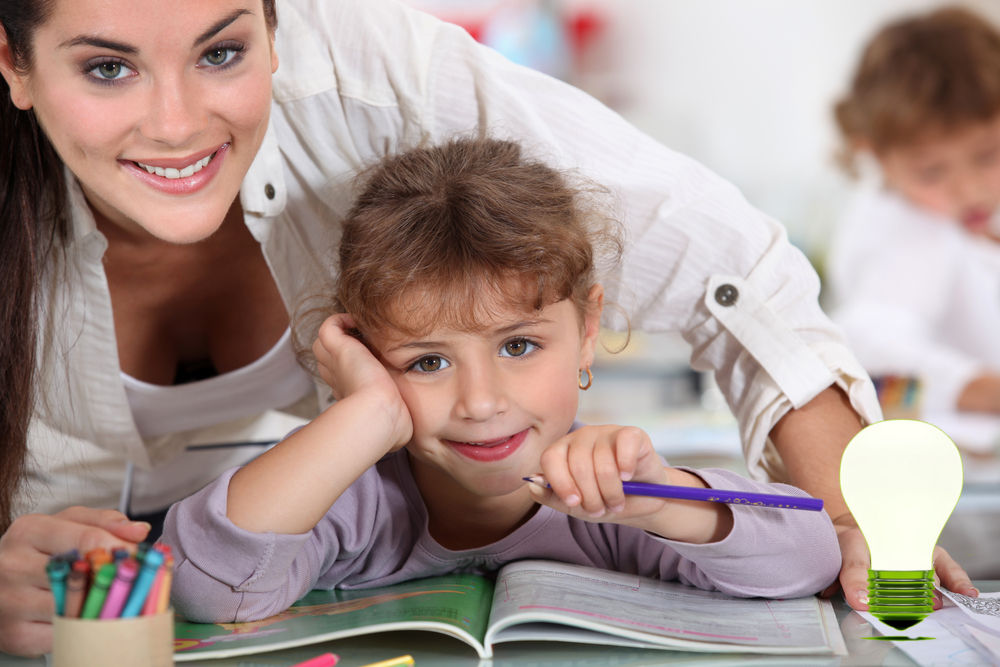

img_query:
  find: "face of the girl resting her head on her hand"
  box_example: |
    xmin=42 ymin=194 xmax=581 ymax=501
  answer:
xmin=372 ymin=286 xmax=603 ymax=507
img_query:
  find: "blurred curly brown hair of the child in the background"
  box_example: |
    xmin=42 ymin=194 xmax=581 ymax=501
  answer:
xmin=833 ymin=7 xmax=1000 ymax=172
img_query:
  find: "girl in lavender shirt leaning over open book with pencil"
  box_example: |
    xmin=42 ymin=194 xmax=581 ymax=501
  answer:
xmin=164 ymin=139 xmax=840 ymax=622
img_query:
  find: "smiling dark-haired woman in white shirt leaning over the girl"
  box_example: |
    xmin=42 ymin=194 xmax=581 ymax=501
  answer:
xmin=0 ymin=0 xmax=969 ymax=654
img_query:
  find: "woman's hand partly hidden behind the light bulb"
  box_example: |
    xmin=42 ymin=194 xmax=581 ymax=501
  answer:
xmin=823 ymin=514 xmax=979 ymax=611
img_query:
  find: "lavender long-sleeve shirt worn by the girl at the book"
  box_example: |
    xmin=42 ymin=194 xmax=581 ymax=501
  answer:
xmin=163 ymin=451 xmax=840 ymax=622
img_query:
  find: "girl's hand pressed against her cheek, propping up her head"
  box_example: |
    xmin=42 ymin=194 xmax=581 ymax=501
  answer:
xmin=313 ymin=313 xmax=413 ymax=451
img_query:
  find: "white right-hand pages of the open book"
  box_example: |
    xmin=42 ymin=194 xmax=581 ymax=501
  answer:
xmin=486 ymin=561 xmax=843 ymax=654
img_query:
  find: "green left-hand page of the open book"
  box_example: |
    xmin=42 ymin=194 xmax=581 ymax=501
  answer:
xmin=174 ymin=574 xmax=493 ymax=662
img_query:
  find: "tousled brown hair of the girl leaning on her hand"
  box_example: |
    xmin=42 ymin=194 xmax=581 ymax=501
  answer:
xmin=335 ymin=138 xmax=621 ymax=342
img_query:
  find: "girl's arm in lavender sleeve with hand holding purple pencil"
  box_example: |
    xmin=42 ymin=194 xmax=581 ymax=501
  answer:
xmin=531 ymin=426 xmax=840 ymax=597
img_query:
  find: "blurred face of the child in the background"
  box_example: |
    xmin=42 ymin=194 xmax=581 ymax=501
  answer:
xmin=878 ymin=117 xmax=1000 ymax=233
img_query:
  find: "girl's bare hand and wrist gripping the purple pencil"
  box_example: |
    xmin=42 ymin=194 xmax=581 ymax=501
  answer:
xmin=529 ymin=425 xmax=733 ymax=543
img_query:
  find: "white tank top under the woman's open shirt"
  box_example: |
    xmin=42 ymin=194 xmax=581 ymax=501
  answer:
xmin=122 ymin=329 xmax=315 ymax=438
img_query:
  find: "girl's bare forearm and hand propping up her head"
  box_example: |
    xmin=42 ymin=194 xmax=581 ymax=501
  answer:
xmin=226 ymin=315 xmax=413 ymax=534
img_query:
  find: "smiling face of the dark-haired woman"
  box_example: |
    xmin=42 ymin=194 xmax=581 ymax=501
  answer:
xmin=0 ymin=0 xmax=278 ymax=243
